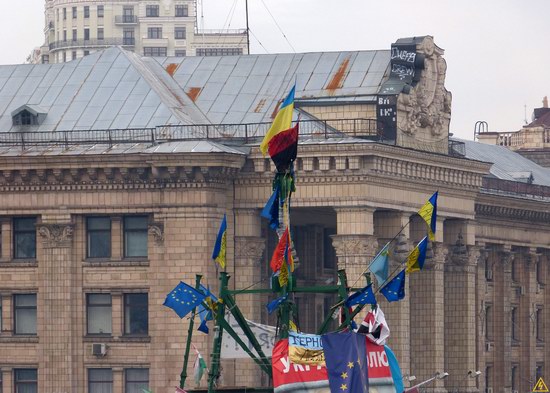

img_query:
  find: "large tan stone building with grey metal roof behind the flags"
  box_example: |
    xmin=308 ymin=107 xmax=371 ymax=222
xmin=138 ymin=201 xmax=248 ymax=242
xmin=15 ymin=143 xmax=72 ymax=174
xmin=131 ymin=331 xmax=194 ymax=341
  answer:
xmin=0 ymin=37 xmax=550 ymax=393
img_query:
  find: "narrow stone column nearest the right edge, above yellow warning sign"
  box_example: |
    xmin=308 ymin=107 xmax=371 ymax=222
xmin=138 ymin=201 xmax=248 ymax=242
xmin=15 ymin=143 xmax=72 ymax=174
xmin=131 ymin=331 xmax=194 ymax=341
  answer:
xmin=518 ymin=249 xmax=539 ymax=392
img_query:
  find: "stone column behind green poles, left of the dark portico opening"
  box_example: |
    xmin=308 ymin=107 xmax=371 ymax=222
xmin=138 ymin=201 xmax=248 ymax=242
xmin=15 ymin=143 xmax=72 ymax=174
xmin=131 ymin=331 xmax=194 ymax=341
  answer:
xmin=232 ymin=209 xmax=269 ymax=386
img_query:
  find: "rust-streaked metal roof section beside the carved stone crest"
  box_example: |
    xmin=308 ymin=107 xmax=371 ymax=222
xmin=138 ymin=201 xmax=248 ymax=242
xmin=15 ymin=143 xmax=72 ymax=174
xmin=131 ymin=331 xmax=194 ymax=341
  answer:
xmin=160 ymin=50 xmax=390 ymax=124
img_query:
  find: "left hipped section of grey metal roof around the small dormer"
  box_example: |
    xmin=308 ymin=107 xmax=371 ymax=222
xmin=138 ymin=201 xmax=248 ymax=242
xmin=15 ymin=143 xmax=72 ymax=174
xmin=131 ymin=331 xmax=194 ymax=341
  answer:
xmin=0 ymin=48 xmax=208 ymax=132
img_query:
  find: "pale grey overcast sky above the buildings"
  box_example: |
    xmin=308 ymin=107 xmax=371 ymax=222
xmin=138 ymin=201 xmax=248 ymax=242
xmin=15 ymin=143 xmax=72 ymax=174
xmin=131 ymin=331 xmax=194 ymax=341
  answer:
xmin=0 ymin=0 xmax=550 ymax=139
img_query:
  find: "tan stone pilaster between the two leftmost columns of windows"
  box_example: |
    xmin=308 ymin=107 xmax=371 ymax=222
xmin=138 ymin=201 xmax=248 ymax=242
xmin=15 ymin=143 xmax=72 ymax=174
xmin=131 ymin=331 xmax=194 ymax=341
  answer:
xmin=37 ymin=215 xmax=75 ymax=393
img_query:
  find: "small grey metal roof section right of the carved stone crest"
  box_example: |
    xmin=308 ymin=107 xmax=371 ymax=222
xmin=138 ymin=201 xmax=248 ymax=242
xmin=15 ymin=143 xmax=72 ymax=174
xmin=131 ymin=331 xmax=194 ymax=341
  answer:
xmin=464 ymin=139 xmax=550 ymax=186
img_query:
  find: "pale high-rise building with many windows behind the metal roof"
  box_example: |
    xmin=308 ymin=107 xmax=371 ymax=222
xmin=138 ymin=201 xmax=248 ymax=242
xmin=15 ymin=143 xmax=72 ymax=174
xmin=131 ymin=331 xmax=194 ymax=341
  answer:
xmin=36 ymin=0 xmax=247 ymax=63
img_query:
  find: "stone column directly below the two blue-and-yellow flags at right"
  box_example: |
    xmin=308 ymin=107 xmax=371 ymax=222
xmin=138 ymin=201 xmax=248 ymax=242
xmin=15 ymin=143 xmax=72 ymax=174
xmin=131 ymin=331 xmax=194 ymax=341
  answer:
xmin=408 ymin=242 xmax=448 ymax=392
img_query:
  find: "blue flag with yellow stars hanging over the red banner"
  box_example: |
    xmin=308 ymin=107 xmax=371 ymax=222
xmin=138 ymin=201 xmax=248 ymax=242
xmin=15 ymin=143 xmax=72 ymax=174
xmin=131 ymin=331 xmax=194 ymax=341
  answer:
xmin=321 ymin=332 xmax=369 ymax=393
